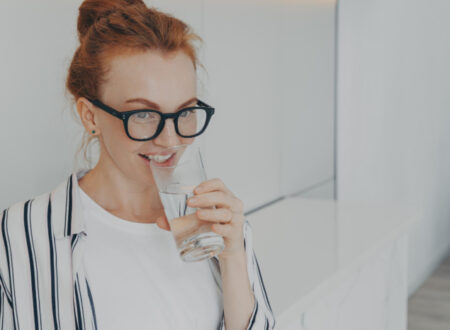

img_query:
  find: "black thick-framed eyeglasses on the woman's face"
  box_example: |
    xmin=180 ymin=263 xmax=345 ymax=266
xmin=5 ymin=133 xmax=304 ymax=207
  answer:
xmin=88 ymin=98 xmax=214 ymax=141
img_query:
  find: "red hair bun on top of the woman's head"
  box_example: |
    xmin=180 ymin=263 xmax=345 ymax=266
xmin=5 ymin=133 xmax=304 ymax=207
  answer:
xmin=77 ymin=0 xmax=147 ymax=38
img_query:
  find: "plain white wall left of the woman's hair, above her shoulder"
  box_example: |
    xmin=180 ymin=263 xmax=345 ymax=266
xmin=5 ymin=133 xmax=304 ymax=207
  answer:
xmin=0 ymin=0 xmax=81 ymax=204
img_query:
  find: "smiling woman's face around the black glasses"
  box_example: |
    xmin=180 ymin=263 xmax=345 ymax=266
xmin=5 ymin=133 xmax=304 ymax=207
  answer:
xmin=81 ymin=51 xmax=197 ymax=183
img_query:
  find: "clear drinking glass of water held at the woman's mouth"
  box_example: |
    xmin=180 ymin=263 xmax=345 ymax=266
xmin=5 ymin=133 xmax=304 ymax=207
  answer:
xmin=150 ymin=143 xmax=225 ymax=261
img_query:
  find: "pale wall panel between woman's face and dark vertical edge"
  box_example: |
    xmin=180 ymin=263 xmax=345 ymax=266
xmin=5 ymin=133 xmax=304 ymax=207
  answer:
xmin=199 ymin=0 xmax=335 ymax=210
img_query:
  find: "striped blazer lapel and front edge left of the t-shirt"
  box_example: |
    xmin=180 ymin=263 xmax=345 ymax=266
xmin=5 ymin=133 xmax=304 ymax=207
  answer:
xmin=49 ymin=170 xmax=97 ymax=330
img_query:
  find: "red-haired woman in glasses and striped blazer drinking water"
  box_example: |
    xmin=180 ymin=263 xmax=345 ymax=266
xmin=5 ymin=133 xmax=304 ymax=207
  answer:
xmin=0 ymin=0 xmax=275 ymax=330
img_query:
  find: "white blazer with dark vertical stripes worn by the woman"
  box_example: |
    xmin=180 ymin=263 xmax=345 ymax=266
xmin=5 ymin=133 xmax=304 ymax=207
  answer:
xmin=0 ymin=170 xmax=275 ymax=330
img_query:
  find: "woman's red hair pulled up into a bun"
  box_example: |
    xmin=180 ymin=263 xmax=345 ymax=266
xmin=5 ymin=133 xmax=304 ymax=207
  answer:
xmin=66 ymin=0 xmax=203 ymax=166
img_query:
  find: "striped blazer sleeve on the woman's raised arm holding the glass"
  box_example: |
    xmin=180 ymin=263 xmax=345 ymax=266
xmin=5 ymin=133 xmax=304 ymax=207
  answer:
xmin=219 ymin=219 xmax=275 ymax=330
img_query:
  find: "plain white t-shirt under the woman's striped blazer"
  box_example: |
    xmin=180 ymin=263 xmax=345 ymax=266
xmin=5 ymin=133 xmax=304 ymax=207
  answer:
xmin=79 ymin=184 xmax=223 ymax=330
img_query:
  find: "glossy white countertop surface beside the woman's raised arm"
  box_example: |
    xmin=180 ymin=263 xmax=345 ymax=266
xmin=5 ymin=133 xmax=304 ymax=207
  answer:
xmin=247 ymin=197 xmax=419 ymax=328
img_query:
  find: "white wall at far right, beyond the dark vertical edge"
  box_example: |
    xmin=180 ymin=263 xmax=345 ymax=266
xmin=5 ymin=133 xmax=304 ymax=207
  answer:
xmin=337 ymin=0 xmax=450 ymax=294
